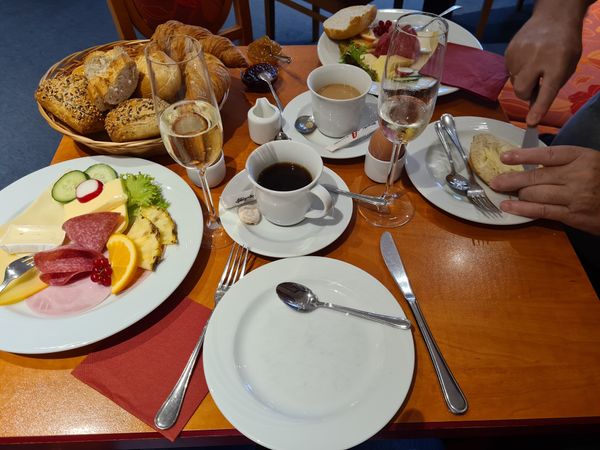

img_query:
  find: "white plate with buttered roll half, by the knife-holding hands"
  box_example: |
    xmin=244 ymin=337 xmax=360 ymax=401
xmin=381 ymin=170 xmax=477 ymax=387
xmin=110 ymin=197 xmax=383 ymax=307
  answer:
xmin=405 ymin=116 xmax=546 ymax=225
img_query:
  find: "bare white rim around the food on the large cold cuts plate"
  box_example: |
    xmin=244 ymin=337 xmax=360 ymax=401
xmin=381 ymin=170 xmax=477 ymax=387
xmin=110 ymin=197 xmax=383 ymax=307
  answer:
xmin=0 ymin=156 xmax=203 ymax=354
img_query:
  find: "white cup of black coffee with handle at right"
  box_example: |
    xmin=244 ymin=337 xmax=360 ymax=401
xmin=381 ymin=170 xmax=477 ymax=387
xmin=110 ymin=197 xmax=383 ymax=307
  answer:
xmin=246 ymin=141 xmax=333 ymax=226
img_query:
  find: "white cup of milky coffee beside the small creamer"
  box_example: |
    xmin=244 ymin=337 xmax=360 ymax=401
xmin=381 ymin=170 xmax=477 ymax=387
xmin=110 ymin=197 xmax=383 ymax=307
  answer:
xmin=306 ymin=64 xmax=372 ymax=138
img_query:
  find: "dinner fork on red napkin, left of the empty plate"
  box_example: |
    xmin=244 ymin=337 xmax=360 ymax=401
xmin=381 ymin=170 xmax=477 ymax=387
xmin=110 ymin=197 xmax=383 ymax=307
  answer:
xmin=154 ymin=243 xmax=248 ymax=430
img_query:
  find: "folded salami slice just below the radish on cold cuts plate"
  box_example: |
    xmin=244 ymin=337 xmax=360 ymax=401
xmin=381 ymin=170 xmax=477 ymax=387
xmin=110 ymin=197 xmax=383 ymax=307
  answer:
xmin=63 ymin=212 xmax=122 ymax=252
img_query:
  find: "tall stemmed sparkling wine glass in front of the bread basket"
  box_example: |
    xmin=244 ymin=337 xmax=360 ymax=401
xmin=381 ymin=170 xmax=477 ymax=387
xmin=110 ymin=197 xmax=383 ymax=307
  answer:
xmin=145 ymin=34 xmax=231 ymax=248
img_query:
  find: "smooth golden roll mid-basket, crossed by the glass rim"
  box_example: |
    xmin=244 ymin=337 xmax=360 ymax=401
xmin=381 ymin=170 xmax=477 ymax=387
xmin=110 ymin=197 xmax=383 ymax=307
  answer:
xmin=134 ymin=51 xmax=181 ymax=102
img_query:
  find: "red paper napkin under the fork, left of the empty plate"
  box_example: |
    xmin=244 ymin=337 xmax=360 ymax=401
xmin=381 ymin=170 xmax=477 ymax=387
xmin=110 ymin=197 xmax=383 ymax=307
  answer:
xmin=72 ymin=297 xmax=210 ymax=441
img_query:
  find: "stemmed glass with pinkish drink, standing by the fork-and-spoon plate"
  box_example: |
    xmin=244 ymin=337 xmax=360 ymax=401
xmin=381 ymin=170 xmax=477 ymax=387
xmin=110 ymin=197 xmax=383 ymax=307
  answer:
xmin=358 ymin=12 xmax=448 ymax=228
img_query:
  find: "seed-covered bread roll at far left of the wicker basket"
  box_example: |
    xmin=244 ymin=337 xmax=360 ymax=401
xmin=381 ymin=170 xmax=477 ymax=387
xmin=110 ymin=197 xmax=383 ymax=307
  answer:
xmin=35 ymin=74 xmax=104 ymax=134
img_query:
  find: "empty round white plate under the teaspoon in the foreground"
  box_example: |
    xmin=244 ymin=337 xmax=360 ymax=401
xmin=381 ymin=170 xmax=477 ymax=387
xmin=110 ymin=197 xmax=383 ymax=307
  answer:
xmin=203 ymin=256 xmax=415 ymax=450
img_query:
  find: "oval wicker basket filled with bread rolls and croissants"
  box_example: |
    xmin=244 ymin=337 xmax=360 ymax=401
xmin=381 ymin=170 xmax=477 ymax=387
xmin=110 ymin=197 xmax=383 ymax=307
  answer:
xmin=35 ymin=20 xmax=248 ymax=156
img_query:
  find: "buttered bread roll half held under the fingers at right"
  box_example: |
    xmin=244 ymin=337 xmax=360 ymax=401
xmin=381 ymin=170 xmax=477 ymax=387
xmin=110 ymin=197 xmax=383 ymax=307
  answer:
xmin=469 ymin=133 xmax=524 ymax=185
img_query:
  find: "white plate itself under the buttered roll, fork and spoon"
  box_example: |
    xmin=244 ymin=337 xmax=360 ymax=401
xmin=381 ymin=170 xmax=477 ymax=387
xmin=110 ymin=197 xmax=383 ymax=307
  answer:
xmin=406 ymin=116 xmax=545 ymax=225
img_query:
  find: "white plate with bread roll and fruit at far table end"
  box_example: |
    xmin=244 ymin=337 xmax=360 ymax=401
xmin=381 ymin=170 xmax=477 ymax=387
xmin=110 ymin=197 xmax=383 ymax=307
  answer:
xmin=317 ymin=5 xmax=483 ymax=95
